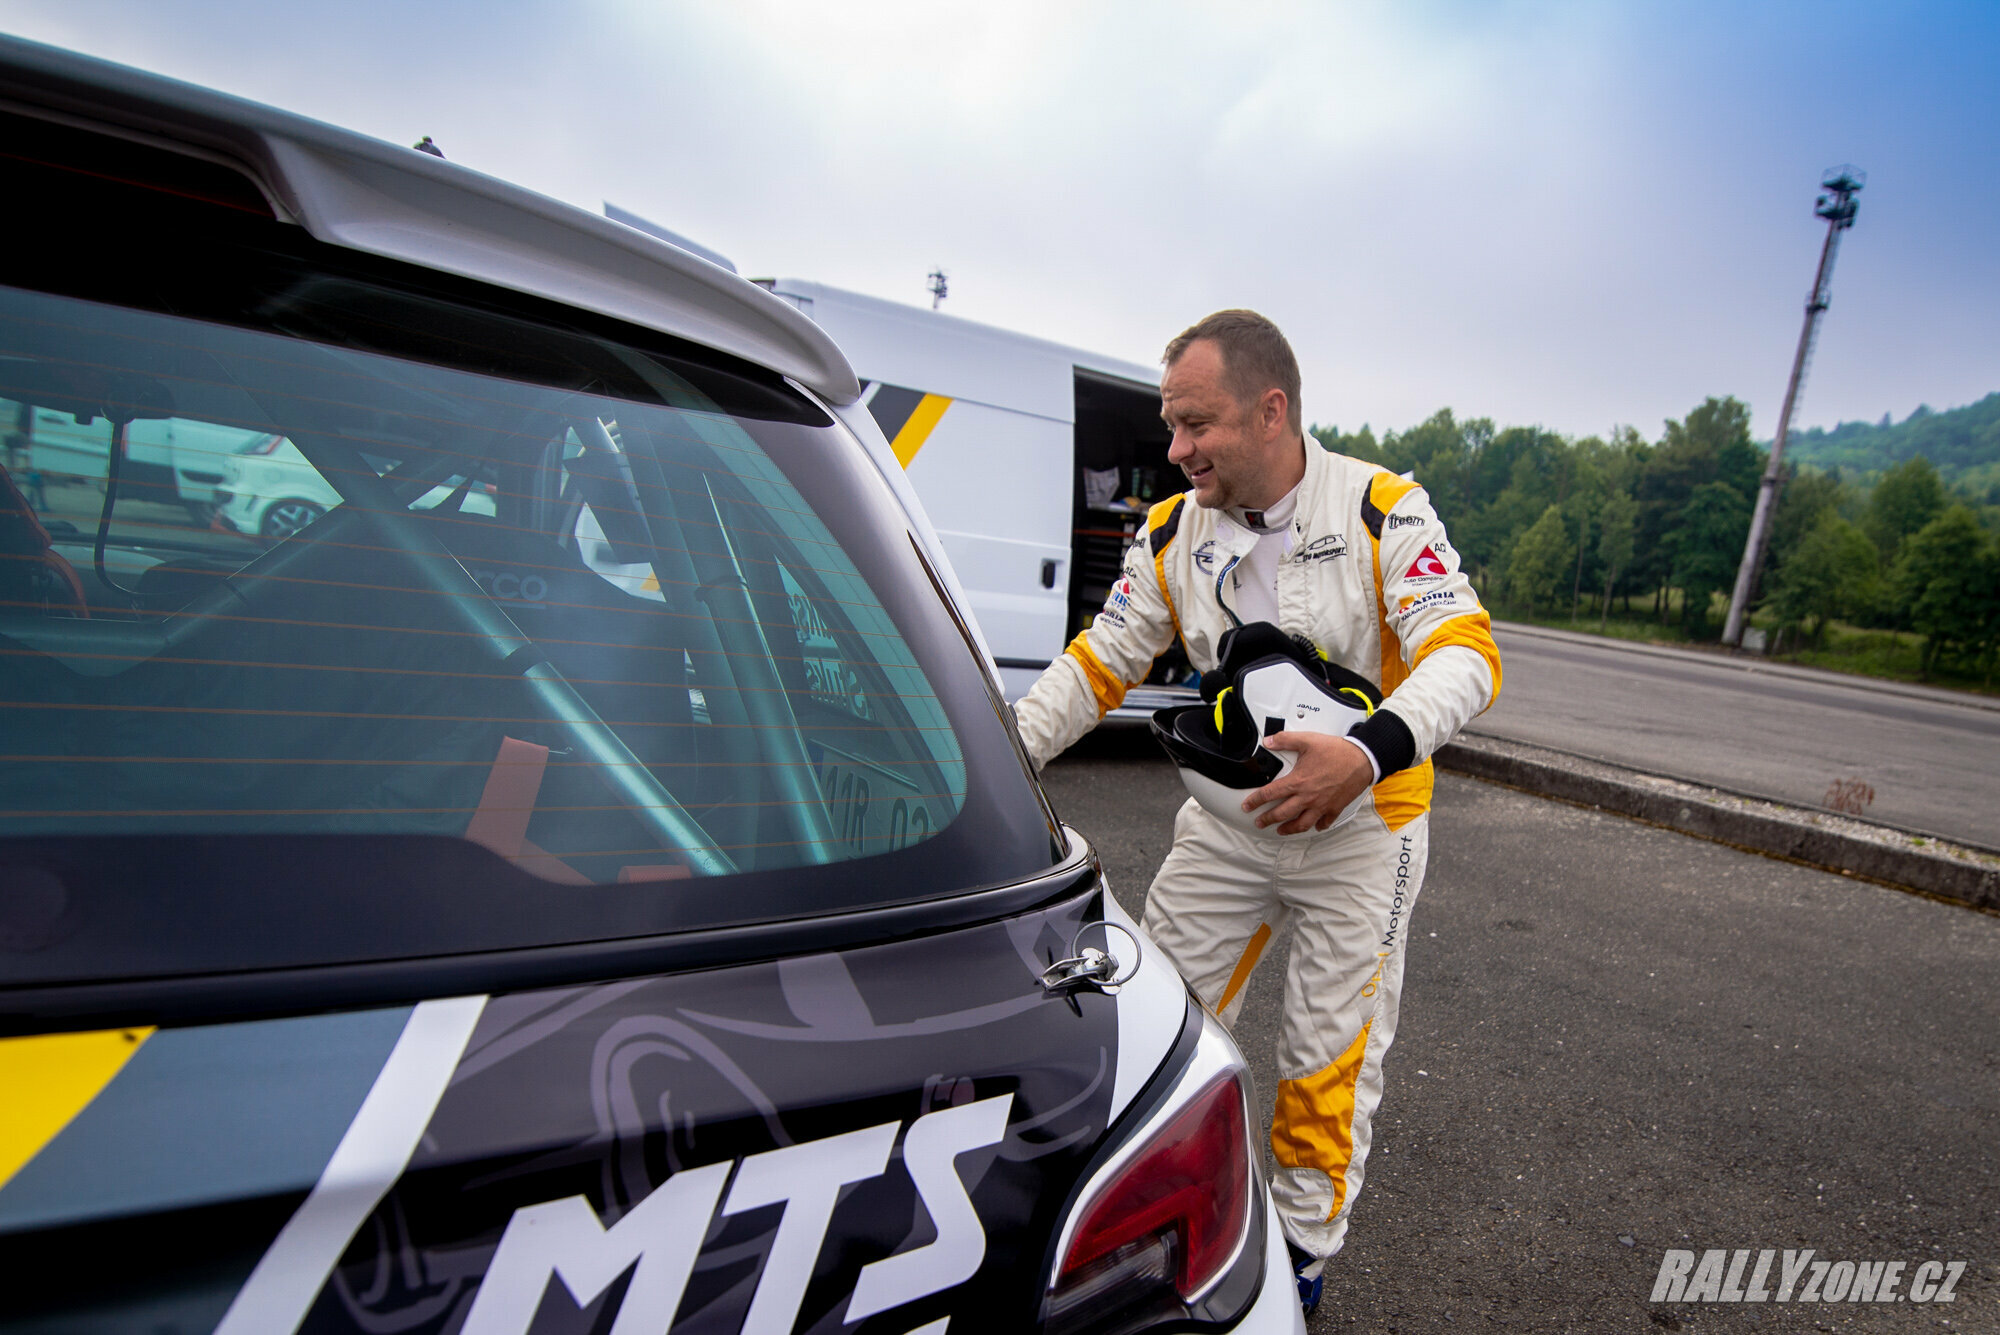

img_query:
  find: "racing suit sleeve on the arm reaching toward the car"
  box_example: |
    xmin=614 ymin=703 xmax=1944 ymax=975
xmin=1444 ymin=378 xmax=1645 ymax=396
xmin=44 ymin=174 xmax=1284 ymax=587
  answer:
xmin=1014 ymin=496 xmax=1186 ymax=769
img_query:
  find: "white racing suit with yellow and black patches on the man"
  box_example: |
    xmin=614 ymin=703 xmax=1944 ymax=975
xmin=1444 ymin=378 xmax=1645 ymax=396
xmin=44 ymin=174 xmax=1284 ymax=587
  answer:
xmin=1016 ymin=444 xmax=1500 ymax=1257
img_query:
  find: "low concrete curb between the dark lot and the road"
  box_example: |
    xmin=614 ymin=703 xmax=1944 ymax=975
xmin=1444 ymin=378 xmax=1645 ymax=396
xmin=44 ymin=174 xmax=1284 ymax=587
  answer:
xmin=1432 ymin=735 xmax=2000 ymax=911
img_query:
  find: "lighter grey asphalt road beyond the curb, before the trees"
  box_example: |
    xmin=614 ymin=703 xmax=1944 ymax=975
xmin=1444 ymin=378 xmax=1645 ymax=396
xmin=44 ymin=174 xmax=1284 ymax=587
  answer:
xmin=1472 ymin=626 xmax=2000 ymax=847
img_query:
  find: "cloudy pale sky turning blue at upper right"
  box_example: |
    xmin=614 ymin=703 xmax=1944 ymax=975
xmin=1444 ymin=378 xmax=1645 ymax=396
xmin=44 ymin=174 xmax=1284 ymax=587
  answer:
xmin=0 ymin=0 xmax=2000 ymax=438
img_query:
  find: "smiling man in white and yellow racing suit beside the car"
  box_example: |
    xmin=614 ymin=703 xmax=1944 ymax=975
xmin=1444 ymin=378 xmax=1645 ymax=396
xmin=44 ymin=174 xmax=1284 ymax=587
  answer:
xmin=1018 ymin=312 xmax=1500 ymax=1311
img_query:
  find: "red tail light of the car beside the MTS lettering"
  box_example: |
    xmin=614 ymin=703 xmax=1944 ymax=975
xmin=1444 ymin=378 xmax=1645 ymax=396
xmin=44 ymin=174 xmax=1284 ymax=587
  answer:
xmin=1044 ymin=1013 xmax=1264 ymax=1335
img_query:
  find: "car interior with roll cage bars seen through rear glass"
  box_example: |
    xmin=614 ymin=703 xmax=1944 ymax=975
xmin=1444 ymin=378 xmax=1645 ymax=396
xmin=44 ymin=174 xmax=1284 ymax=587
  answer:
xmin=0 ymin=273 xmax=964 ymax=883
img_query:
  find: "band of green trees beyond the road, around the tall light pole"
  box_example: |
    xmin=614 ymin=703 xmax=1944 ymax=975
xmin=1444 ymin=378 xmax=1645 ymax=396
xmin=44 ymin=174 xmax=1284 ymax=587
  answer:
xmin=1312 ymin=385 xmax=2000 ymax=651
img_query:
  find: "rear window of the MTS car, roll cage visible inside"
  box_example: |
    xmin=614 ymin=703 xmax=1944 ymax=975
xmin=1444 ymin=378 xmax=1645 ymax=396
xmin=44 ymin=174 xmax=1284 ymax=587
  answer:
xmin=0 ymin=132 xmax=1052 ymax=971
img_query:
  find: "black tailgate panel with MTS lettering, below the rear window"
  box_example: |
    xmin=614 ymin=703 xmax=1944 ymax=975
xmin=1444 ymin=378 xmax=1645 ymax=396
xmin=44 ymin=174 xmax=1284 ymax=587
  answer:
xmin=0 ymin=891 xmax=1152 ymax=1335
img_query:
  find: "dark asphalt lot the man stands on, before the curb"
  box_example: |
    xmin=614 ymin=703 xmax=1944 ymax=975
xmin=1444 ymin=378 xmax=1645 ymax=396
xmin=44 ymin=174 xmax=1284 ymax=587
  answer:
xmin=1044 ymin=731 xmax=2000 ymax=1333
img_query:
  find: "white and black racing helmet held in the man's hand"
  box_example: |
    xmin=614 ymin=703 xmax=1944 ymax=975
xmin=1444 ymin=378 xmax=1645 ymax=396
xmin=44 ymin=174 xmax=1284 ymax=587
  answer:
xmin=1152 ymin=622 xmax=1382 ymax=837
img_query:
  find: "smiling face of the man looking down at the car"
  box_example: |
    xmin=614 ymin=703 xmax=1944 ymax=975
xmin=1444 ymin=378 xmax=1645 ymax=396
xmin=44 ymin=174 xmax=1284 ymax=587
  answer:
xmin=1160 ymin=338 xmax=1286 ymax=510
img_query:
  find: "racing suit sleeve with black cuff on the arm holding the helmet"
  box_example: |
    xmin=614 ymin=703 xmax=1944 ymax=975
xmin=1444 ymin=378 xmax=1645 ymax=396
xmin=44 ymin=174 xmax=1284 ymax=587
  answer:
xmin=1352 ymin=474 xmax=1500 ymax=775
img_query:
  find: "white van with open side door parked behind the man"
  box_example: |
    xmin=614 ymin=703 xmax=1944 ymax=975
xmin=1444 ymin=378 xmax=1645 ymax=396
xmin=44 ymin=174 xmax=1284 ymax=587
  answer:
xmin=760 ymin=278 xmax=1194 ymax=717
